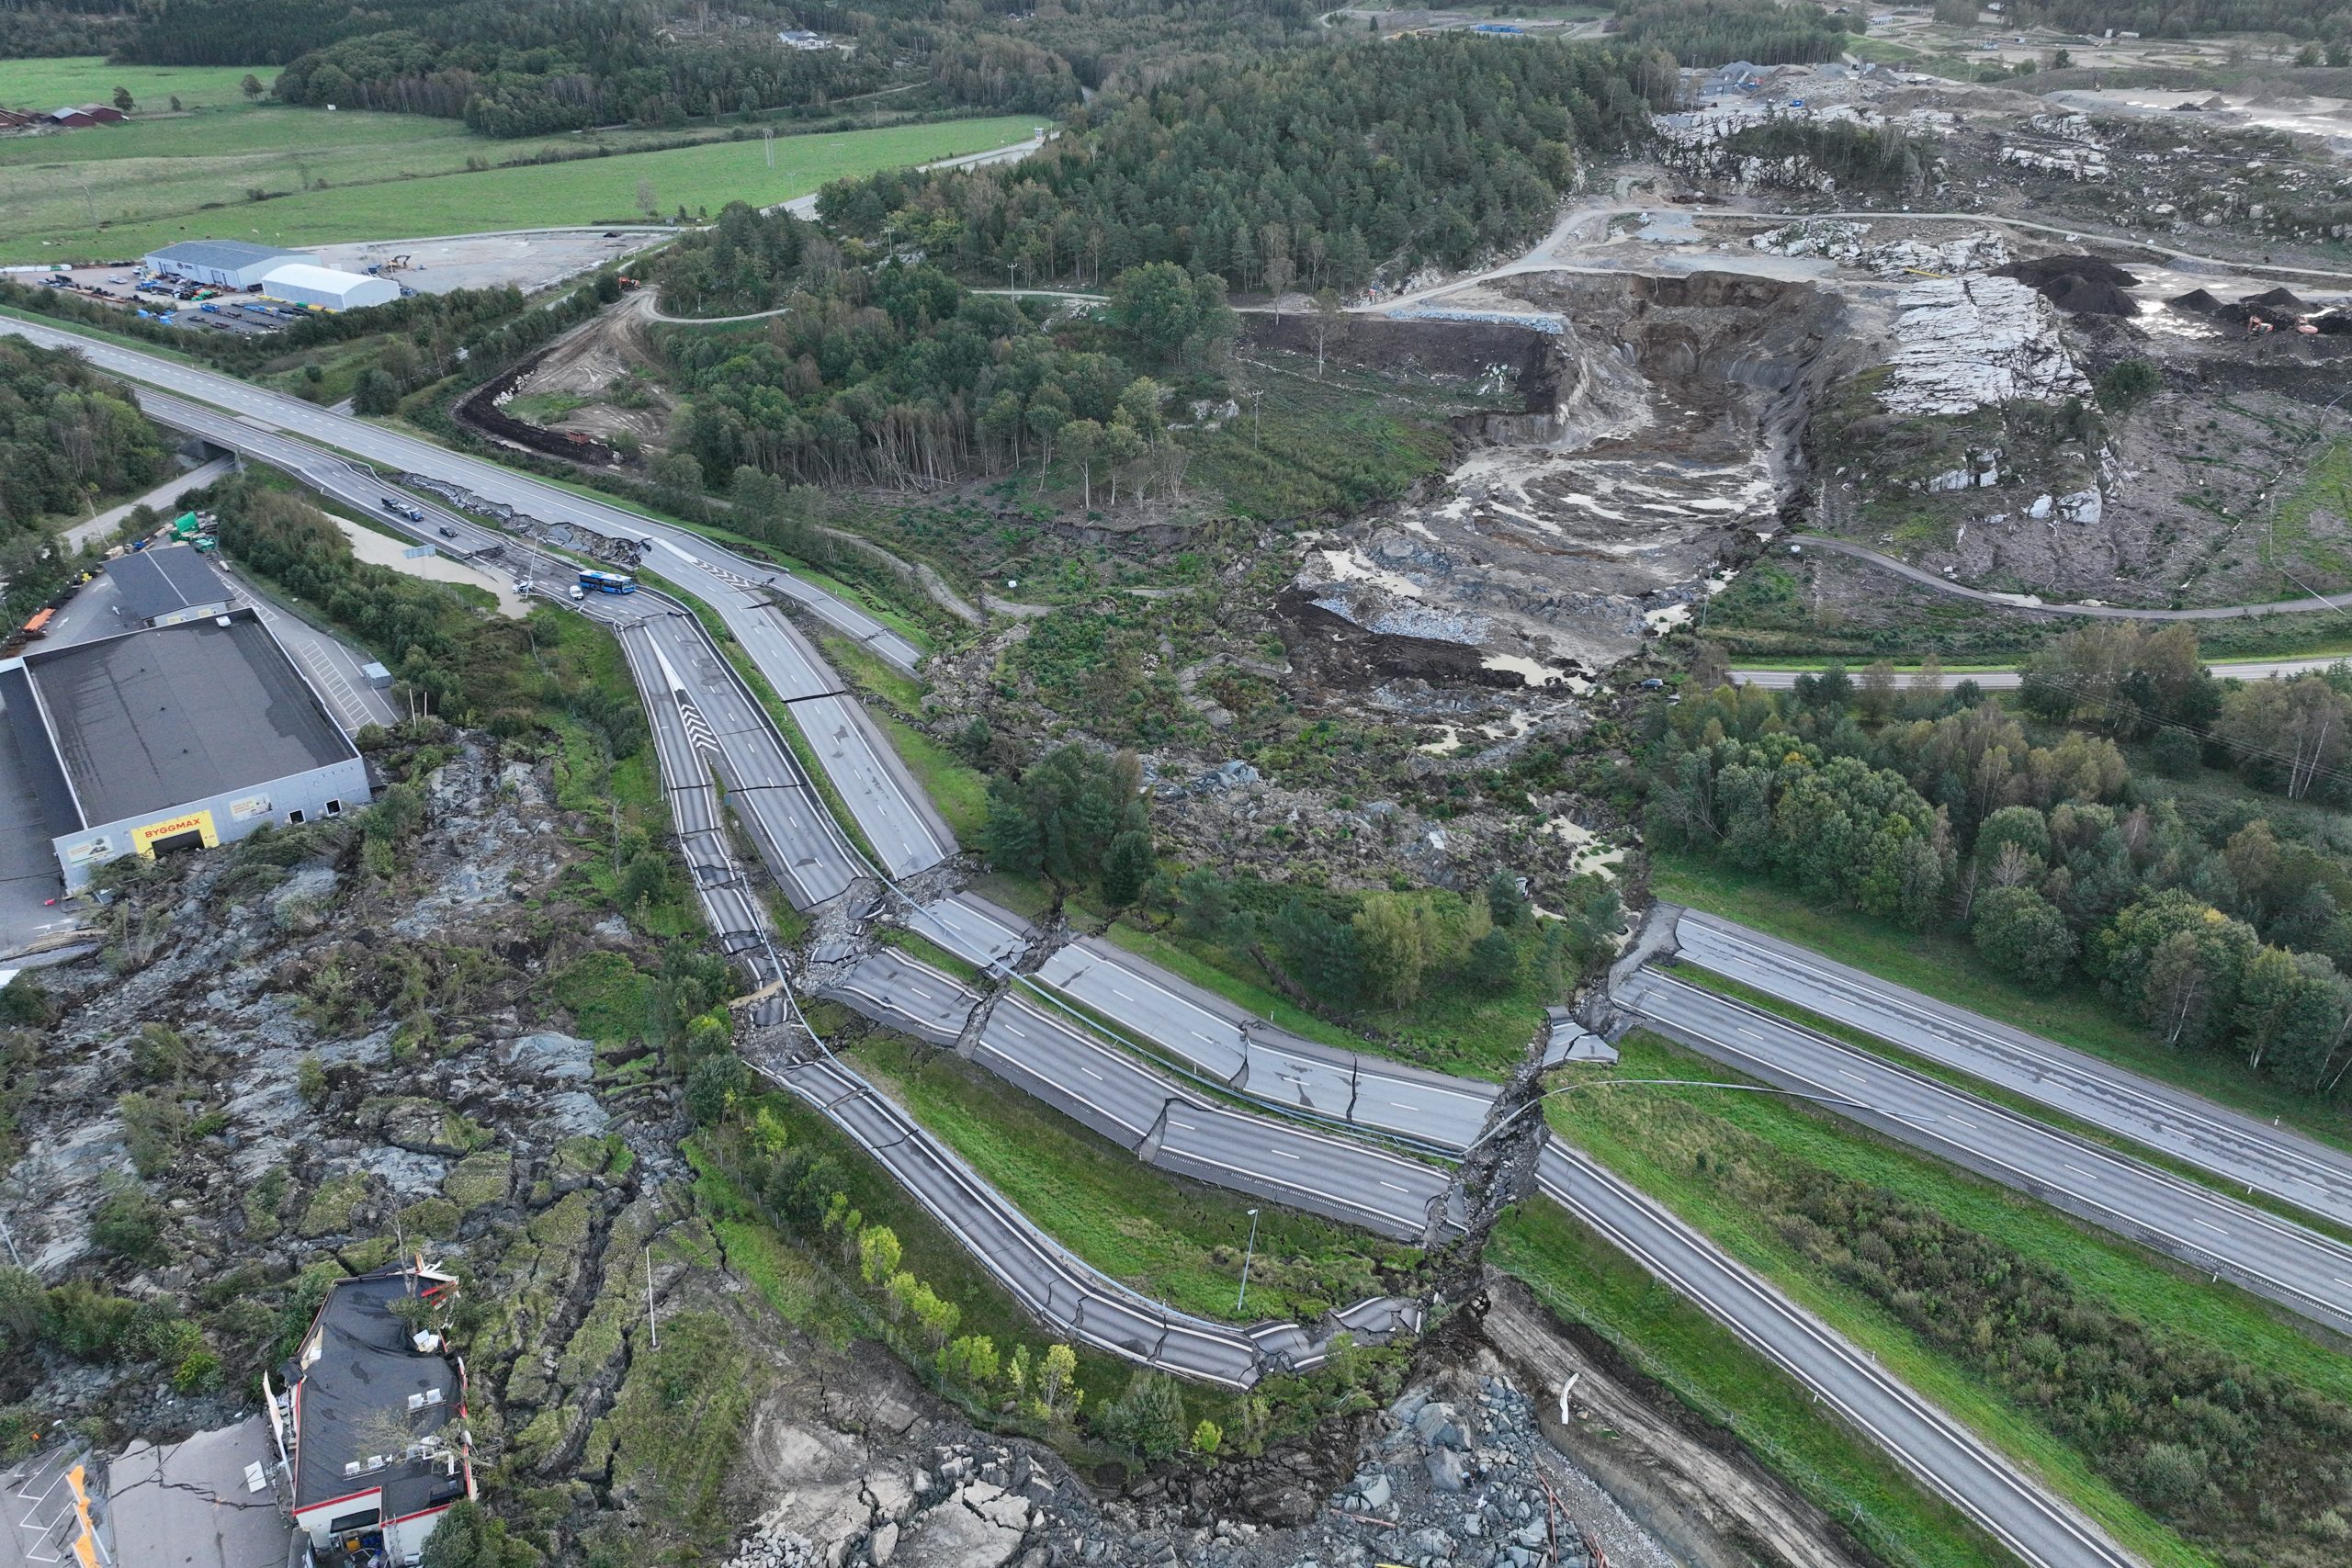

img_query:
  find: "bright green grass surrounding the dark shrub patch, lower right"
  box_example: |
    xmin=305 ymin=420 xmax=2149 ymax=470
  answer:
xmin=1547 ymin=1034 xmax=2352 ymax=1568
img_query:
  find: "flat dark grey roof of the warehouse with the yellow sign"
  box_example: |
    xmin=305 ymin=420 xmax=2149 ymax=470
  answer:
xmin=24 ymin=609 xmax=360 ymax=828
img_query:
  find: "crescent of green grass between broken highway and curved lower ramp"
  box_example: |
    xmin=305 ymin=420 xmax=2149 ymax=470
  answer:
xmin=849 ymin=1034 xmax=1414 ymax=1324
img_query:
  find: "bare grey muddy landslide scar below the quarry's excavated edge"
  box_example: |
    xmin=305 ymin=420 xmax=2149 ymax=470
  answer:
xmin=1294 ymin=273 xmax=1834 ymax=691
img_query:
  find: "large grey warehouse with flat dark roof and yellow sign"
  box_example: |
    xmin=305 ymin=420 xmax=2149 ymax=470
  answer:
xmin=0 ymin=609 xmax=367 ymax=891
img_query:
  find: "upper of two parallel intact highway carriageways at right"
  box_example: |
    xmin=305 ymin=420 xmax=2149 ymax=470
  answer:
xmin=1675 ymin=909 xmax=2352 ymax=1224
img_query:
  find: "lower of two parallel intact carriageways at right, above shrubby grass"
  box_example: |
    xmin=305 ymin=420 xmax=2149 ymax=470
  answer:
xmin=1613 ymin=968 xmax=2352 ymax=1333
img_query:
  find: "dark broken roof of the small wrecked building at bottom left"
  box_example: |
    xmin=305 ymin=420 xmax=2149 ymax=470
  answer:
xmin=289 ymin=1269 xmax=466 ymax=1518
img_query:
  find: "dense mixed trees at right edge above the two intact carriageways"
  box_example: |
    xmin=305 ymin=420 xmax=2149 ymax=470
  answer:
xmin=1649 ymin=623 xmax=2352 ymax=1093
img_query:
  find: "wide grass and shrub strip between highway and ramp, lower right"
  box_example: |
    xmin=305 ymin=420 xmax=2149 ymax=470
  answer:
xmin=1550 ymin=1034 xmax=2352 ymax=1565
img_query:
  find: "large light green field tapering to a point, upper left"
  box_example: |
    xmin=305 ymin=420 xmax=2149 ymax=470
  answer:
xmin=0 ymin=62 xmax=1040 ymax=261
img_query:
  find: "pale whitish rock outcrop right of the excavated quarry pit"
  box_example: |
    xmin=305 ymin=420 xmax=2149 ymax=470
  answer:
xmin=1882 ymin=275 xmax=2091 ymax=413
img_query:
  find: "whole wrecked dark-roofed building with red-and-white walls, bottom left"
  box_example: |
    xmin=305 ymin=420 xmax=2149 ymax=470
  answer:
xmin=261 ymin=1262 xmax=475 ymax=1563
